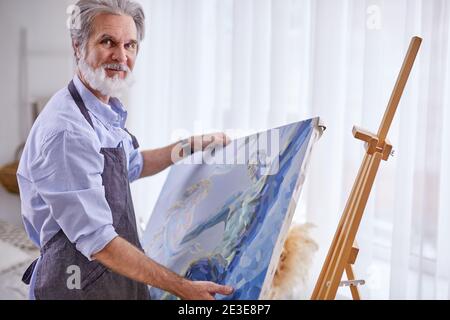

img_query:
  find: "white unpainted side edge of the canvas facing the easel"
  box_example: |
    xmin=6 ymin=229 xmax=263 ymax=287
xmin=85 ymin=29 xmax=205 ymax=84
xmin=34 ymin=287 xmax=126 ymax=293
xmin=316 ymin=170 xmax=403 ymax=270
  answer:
xmin=258 ymin=118 xmax=326 ymax=300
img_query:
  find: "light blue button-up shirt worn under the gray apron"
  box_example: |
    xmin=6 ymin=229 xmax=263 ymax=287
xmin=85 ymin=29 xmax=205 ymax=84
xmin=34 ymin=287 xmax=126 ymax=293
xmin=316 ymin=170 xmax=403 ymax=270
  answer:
xmin=17 ymin=76 xmax=143 ymax=290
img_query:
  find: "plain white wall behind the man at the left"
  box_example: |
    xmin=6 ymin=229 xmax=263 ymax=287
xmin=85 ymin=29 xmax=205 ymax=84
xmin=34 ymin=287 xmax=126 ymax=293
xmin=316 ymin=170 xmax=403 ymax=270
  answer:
xmin=0 ymin=0 xmax=72 ymax=224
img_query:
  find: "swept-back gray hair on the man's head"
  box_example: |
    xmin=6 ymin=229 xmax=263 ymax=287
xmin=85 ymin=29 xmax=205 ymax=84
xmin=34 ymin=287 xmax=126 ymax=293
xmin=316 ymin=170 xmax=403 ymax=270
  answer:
xmin=70 ymin=0 xmax=145 ymax=61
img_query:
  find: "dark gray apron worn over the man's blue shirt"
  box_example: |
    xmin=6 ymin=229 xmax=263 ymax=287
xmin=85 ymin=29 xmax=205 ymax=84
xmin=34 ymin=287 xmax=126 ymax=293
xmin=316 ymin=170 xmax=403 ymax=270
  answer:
xmin=23 ymin=81 xmax=150 ymax=300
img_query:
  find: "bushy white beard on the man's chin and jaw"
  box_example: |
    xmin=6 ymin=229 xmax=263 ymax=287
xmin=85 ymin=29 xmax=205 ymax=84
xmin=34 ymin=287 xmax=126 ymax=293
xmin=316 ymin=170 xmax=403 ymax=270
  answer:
xmin=78 ymin=57 xmax=134 ymax=97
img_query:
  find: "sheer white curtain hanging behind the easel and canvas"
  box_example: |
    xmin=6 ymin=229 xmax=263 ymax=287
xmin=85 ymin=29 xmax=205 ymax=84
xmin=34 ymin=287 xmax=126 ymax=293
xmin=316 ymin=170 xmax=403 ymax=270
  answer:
xmin=129 ymin=0 xmax=450 ymax=299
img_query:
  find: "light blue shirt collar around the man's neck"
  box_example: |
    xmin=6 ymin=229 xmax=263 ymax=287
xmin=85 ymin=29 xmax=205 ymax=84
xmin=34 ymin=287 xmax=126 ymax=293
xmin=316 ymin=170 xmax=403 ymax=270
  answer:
xmin=73 ymin=75 xmax=127 ymax=128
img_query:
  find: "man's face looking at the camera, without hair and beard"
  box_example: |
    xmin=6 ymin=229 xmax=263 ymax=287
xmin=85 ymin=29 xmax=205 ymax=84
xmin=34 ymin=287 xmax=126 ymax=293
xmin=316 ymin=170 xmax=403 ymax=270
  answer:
xmin=81 ymin=14 xmax=138 ymax=79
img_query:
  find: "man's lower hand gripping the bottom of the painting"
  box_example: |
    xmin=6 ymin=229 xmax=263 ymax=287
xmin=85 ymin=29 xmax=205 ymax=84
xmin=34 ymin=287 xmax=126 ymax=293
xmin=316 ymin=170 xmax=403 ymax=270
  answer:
xmin=177 ymin=280 xmax=234 ymax=300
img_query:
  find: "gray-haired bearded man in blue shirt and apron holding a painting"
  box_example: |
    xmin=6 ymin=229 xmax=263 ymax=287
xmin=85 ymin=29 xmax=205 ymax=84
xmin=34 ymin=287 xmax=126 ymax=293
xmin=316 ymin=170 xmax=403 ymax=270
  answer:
xmin=17 ymin=0 xmax=233 ymax=300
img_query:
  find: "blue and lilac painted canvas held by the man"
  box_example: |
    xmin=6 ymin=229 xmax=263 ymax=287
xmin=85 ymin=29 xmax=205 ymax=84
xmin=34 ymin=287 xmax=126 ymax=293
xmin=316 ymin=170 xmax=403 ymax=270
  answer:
xmin=142 ymin=118 xmax=322 ymax=300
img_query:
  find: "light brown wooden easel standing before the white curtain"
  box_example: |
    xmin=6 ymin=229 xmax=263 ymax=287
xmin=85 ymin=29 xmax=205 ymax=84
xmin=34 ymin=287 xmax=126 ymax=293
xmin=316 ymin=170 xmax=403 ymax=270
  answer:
xmin=311 ymin=37 xmax=422 ymax=300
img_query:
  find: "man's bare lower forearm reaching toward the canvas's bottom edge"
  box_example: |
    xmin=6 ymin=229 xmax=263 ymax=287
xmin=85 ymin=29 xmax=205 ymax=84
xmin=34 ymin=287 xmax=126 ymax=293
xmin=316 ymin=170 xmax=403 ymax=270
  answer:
xmin=93 ymin=237 xmax=187 ymax=296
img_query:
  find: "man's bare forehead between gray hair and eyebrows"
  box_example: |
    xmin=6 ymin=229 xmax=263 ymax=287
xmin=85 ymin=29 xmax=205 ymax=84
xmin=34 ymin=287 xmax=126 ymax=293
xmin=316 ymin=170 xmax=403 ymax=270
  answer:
xmin=92 ymin=14 xmax=137 ymax=40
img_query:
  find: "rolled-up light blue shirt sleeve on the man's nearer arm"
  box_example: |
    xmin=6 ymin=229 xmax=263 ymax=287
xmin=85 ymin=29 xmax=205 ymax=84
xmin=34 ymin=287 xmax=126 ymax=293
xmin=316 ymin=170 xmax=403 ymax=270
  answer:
xmin=30 ymin=131 xmax=117 ymax=260
